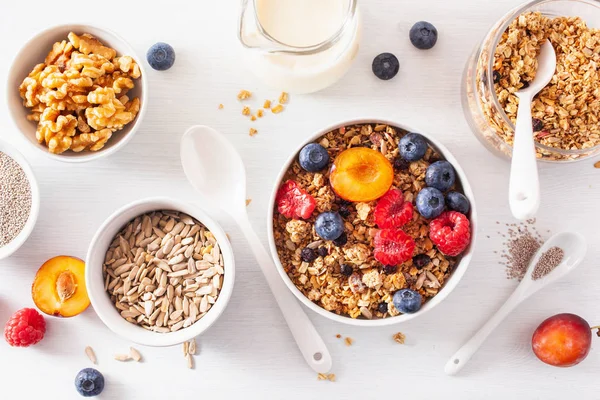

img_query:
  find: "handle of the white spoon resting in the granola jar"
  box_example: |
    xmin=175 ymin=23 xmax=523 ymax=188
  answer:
xmin=508 ymin=95 xmax=540 ymax=220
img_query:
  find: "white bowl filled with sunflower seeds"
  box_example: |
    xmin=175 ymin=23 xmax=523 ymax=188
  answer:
xmin=85 ymin=198 xmax=235 ymax=346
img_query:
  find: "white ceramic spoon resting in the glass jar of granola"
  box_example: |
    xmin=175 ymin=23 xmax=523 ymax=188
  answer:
xmin=508 ymin=40 xmax=556 ymax=220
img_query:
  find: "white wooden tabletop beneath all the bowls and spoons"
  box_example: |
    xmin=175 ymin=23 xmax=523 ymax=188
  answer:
xmin=0 ymin=0 xmax=600 ymax=399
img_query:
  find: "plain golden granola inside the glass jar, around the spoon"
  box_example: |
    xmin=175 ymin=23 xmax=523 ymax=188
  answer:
xmin=477 ymin=12 xmax=600 ymax=159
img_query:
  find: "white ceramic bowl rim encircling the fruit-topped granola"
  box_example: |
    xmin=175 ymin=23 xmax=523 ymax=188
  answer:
xmin=267 ymin=118 xmax=477 ymax=326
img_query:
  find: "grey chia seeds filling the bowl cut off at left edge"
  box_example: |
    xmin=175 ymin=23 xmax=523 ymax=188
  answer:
xmin=0 ymin=152 xmax=31 ymax=247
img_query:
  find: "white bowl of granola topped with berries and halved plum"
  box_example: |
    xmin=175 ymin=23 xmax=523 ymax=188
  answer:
xmin=268 ymin=119 xmax=476 ymax=326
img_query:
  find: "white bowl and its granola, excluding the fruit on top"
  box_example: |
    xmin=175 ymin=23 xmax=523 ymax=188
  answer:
xmin=267 ymin=119 xmax=477 ymax=326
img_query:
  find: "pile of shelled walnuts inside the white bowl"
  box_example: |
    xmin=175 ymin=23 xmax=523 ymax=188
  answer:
xmin=19 ymin=32 xmax=141 ymax=154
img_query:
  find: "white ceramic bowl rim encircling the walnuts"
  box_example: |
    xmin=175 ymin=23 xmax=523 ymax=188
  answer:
xmin=5 ymin=23 xmax=148 ymax=163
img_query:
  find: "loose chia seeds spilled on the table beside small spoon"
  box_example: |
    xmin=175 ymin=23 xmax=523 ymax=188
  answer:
xmin=500 ymin=219 xmax=543 ymax=281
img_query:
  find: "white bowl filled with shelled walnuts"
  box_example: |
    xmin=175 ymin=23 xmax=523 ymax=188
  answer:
xmin=6 ymin=24 xmax=147 ymax=163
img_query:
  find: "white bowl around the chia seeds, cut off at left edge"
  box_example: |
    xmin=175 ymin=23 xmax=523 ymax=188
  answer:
xmin=0 ymin=140 xmax=40 ymax=260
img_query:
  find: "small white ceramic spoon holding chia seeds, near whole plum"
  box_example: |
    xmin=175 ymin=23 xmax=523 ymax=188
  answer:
xmin=445 ymin=232 xmax=587 ymax=375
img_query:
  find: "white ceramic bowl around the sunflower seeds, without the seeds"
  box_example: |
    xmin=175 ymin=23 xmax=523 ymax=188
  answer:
xmin=85 ymin=197 xmax=235 ymax=346
